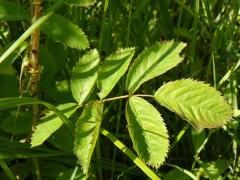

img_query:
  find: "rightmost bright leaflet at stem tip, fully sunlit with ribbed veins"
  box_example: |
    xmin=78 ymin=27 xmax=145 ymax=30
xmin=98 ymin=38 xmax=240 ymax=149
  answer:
xmin=154 ymin=79 xmax=232 ymax=128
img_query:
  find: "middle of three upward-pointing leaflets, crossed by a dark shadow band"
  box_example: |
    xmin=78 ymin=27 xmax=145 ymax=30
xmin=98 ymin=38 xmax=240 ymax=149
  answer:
xmin=98 ymin=48 xmax=135 ymax=99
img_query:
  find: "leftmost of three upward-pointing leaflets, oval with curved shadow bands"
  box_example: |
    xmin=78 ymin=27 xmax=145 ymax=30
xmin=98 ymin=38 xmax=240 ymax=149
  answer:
xmin=71 ymin=49 xmax=100 ymax=104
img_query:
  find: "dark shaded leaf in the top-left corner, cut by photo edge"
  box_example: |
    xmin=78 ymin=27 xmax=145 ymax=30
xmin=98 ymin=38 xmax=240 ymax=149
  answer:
xmin=0 ymin=0 xmax=29 ymax=21
